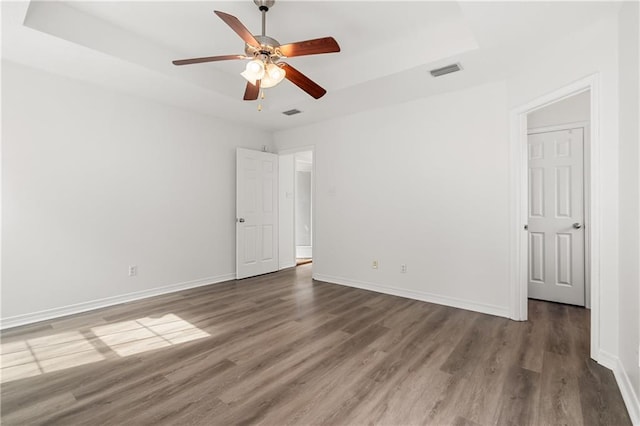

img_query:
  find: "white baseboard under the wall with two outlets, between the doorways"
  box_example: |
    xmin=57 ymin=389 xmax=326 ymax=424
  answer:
xmin=313 ymin=274 xmax=509 ymax=318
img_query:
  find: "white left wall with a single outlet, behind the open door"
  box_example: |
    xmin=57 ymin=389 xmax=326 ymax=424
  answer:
xmin=2 ymin=62 xmax=271 ymax=326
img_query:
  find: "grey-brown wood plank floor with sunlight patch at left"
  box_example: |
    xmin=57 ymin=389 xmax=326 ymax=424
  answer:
xmin=1 ymin=265 xmax=631 ymax=425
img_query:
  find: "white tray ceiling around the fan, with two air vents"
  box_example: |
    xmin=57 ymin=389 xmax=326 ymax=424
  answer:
xmin=2 ymin=0 xmax=619 ymax=130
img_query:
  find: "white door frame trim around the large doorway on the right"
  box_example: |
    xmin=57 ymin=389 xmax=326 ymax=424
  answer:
xmin=509 ymin=73 xmax=602 ymax=361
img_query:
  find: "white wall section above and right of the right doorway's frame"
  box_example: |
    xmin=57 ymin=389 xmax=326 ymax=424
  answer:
xmin=508 ymin=19 xmax=619 ymax=359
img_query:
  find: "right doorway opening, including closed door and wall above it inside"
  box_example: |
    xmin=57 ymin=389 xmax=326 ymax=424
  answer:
xmin=526 ymin=90 xmax=591 ymax=307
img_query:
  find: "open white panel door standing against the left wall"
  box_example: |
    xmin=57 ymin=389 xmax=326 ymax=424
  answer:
xmin=236 ymin=148 xmax=278 ymax=279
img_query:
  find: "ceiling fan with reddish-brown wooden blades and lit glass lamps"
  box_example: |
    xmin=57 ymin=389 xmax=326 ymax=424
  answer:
xmin=173 ymin=0 xmax=340 ymax=101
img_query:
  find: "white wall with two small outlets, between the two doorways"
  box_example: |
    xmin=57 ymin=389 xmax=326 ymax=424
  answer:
xmin=274 ymin=83 xmax=509 ymax=316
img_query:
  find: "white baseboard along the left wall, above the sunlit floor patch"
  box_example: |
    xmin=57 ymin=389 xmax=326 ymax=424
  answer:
xmin=0 ymin=273 xmax=236 ymax=330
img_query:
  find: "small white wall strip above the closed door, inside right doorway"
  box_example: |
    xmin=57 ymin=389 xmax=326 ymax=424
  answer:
xmin=527 ymin=91 xmax=591 ymax=129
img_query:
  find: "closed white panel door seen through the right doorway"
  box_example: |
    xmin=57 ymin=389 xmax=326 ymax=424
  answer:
xmin=528 ymin=128 xmax=585 ymax=306
